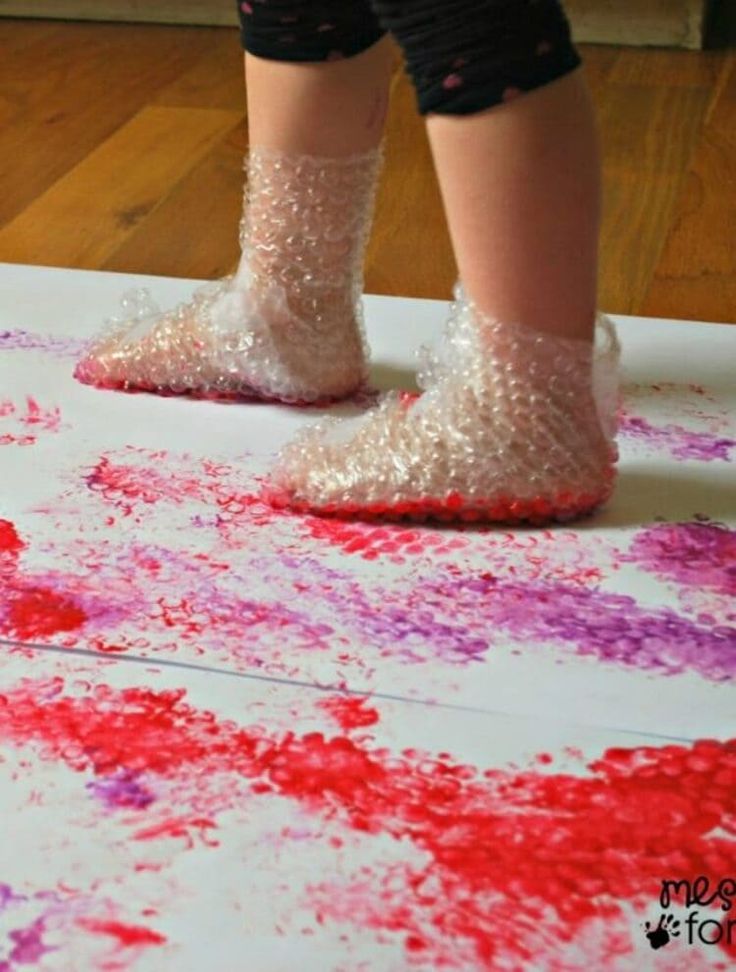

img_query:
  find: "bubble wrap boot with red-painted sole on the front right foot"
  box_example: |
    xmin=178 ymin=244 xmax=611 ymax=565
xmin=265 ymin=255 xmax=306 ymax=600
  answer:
xmin=264 ymin=290 xmax=619 ymax=523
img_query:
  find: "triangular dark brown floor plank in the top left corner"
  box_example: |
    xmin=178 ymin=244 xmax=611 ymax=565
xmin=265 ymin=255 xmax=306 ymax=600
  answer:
xmin=0 ymin=21 xmax=224 ymax=223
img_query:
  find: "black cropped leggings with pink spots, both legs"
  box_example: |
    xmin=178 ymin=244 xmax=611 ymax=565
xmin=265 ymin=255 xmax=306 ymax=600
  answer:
xmin=238 ymin=0 xmax=580 ymax=115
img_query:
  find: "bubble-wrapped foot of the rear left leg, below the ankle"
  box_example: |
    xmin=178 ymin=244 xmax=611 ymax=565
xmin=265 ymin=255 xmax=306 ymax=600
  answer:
xmin=74 ymin=268 xmax=367 ymax=403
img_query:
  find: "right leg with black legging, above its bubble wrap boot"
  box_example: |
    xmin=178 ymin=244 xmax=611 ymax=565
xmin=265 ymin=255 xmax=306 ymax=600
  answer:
xmin=374 ymin=0 xmax=600 ymax=337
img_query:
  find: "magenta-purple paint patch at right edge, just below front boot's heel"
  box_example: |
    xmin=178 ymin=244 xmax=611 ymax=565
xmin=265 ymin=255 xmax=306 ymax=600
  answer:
xmin=621 ymin=523 xmax=736 ymax=595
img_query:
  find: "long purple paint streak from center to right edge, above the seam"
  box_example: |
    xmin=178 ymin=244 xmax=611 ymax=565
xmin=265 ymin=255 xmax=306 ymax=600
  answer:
xmin=237 ymin=556 xmax=736 ymax=681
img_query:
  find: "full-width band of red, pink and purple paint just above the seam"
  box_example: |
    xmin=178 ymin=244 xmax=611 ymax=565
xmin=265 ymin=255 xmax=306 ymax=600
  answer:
xmin=0 ymin=498 xmax=736 ymax=686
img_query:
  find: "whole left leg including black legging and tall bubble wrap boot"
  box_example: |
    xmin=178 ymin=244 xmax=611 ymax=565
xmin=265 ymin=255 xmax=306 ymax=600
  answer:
xmin=76 ymin=0 xmax=392 ymax=402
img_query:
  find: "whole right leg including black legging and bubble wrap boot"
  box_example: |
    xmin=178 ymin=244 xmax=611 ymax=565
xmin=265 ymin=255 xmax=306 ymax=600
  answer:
xmin=271 ymin=0 xmax=617 ymax=520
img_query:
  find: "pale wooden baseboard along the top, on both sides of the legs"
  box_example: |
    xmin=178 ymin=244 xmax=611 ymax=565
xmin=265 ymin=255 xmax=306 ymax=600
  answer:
xmin=0 ymin=0 xmax=712 ymax=49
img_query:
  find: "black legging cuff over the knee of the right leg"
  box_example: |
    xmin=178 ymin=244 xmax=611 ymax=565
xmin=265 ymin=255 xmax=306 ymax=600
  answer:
xmin=372 ymin=0 xmax=580 ymax=115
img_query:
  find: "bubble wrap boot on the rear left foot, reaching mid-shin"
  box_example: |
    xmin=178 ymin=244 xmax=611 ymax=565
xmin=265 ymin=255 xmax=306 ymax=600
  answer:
xmin=75 ymin=149 xmax=381 ymax=403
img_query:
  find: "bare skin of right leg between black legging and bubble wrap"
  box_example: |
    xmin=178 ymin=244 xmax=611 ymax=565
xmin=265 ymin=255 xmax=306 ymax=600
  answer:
xmin=427 ymin=71 xmax=600 ymax=337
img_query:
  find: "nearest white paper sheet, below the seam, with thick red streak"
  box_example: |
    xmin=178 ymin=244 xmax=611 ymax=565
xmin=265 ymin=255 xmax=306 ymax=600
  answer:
xmin=0 ymin=648 xmax=735 ymax=972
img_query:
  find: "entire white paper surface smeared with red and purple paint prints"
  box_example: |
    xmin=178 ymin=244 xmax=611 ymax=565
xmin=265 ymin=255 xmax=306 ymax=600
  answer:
xmin=0 ymin=265 xmax=736 ymax=972
